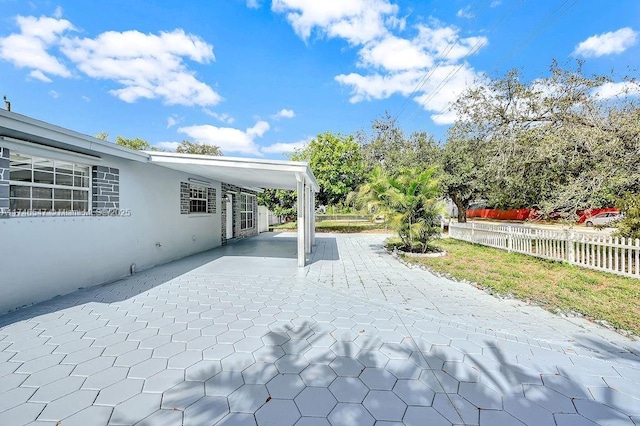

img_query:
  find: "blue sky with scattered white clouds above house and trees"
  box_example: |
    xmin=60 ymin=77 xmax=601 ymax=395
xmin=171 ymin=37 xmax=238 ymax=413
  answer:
xmin=0 ymin=0 xmax=640 ymax=158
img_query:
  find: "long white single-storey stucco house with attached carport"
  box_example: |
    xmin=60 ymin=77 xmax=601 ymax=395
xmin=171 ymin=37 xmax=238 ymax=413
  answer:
xmin=0 ymin=110 xmax=319 ymax=313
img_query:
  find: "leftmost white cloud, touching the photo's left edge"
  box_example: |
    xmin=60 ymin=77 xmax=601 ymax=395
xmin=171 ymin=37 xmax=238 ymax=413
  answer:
xmin=0 ymin=16 xmax=74 ymax=78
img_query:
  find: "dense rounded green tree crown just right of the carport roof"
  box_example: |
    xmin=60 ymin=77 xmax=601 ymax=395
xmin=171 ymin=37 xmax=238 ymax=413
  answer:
xmin=290 ymin=132 xmax=364 ymax=205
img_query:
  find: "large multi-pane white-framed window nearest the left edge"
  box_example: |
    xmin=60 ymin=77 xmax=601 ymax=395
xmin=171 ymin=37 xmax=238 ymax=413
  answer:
xmin=9 ymin=152 xmax=91 ymax=212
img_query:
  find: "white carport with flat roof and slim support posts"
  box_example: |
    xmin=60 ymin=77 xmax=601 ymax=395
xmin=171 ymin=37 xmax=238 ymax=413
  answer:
xmin=146 ymin=151 xmax=320 ymax=267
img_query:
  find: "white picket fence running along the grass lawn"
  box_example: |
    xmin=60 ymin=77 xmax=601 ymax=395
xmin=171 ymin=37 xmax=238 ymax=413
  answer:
xmin=449 ymin=222 xmax=640 ymax=278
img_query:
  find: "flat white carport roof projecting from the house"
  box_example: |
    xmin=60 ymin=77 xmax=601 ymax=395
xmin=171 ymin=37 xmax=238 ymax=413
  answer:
xmin=144 ymin=151 xmax=320 ymax=192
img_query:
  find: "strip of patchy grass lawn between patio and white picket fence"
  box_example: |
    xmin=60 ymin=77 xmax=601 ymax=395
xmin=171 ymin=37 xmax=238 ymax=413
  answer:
xmin=405 ymin=238 xmax=640 ymax=335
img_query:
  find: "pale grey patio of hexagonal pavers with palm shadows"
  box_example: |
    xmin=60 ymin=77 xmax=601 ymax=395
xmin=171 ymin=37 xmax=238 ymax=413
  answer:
xmin=0 ymin=234 xmax=640 ymax=426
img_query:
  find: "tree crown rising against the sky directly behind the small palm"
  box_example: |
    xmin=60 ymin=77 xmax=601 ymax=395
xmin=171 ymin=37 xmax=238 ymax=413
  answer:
xmin=358 ymin=113 xmax=440 ymax=176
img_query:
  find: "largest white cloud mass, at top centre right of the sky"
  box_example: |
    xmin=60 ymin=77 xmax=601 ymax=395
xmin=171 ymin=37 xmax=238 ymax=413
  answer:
xmin=272 ymin=0 xmax=488 ymax=124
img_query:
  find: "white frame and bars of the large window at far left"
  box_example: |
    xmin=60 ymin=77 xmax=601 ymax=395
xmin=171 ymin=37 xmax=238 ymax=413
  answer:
xmin=9 ymin=150 xmax=92 ymax=216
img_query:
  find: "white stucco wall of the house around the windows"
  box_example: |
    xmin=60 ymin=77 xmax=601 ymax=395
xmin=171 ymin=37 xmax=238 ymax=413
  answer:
xmin=0 ymin=147 xmax=221 ymax=312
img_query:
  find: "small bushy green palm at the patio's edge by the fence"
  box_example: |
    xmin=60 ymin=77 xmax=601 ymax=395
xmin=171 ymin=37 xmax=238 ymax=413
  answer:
xmin=361 ymin=167 xmax=440 ymax=253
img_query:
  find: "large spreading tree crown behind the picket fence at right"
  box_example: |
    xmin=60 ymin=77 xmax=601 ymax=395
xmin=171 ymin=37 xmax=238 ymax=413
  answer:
xmin=443 ymin=63 xmax=640 ymax=216
